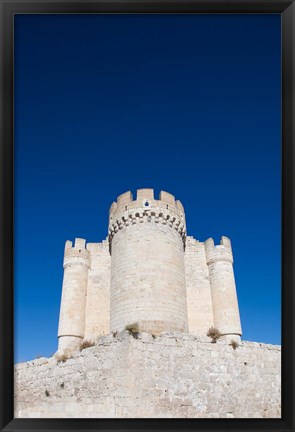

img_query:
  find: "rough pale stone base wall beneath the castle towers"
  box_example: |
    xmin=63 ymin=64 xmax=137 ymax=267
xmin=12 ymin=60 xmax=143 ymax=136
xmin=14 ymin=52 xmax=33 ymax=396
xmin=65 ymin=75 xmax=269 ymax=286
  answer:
xmin=15 ymin=331 xmax=281 ymax=418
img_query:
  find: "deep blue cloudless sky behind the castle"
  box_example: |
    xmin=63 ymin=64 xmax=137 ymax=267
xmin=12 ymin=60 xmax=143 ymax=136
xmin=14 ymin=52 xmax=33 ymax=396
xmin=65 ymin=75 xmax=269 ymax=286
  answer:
xmin=15 ymin=15 xmax=281 ymax=361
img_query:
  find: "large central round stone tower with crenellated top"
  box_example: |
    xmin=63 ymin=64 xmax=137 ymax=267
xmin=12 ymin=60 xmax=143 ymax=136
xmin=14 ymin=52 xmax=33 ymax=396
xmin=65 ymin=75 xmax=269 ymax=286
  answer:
xmin=109 ymin=189 xmax=188 ymax=335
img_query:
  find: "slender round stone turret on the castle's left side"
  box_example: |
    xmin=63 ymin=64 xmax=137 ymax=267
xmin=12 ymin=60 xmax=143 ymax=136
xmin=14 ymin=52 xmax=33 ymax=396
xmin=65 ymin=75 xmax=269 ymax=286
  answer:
xmin=58 ymin=238 xmax=90 ymax=351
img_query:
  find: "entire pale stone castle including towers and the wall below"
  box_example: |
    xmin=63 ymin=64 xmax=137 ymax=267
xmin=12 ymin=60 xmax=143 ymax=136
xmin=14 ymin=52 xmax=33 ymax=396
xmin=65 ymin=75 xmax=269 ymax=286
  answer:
xmin=14 ymin=189 xmax=281 ymax=419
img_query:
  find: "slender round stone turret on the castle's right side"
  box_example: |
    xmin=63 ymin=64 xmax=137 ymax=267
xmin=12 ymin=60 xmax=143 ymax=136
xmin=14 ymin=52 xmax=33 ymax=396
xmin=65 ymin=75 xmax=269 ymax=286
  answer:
xmin=205 ymin=237 xmax=242 ymax=342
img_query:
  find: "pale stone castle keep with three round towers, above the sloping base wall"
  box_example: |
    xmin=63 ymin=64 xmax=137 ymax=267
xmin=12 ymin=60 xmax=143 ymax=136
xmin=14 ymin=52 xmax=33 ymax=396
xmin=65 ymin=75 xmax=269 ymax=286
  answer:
xmin=58 ymin=189 xmax=242 ymax=351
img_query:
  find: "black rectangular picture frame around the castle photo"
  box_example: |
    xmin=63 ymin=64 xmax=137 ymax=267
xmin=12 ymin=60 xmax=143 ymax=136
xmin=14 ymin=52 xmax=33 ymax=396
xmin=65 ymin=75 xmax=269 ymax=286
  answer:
xmin=0 ymin=0 xmax=295 ymax=431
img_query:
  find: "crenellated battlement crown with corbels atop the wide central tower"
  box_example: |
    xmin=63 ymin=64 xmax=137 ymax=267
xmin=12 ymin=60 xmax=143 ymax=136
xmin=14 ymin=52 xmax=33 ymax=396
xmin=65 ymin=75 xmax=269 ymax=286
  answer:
xmin=109 ymin=189 xmax=186 ymax=250
